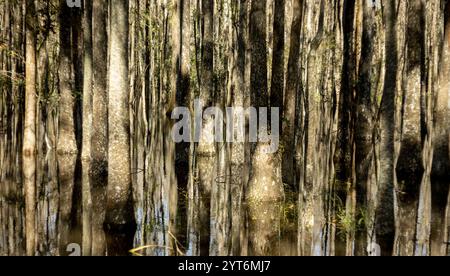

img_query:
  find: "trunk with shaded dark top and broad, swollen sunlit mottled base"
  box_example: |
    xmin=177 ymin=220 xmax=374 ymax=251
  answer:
xmin=246 ymin=0 xmax=284 ymax=256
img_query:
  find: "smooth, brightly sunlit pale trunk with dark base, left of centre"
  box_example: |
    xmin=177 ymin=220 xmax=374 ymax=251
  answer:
xmin=106 ymin=0 xmax=134 ymax=236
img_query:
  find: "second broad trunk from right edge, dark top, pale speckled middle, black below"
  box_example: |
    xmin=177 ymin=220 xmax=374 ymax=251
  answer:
xmin=394 ymin=0 xmax=424 ymax=256
